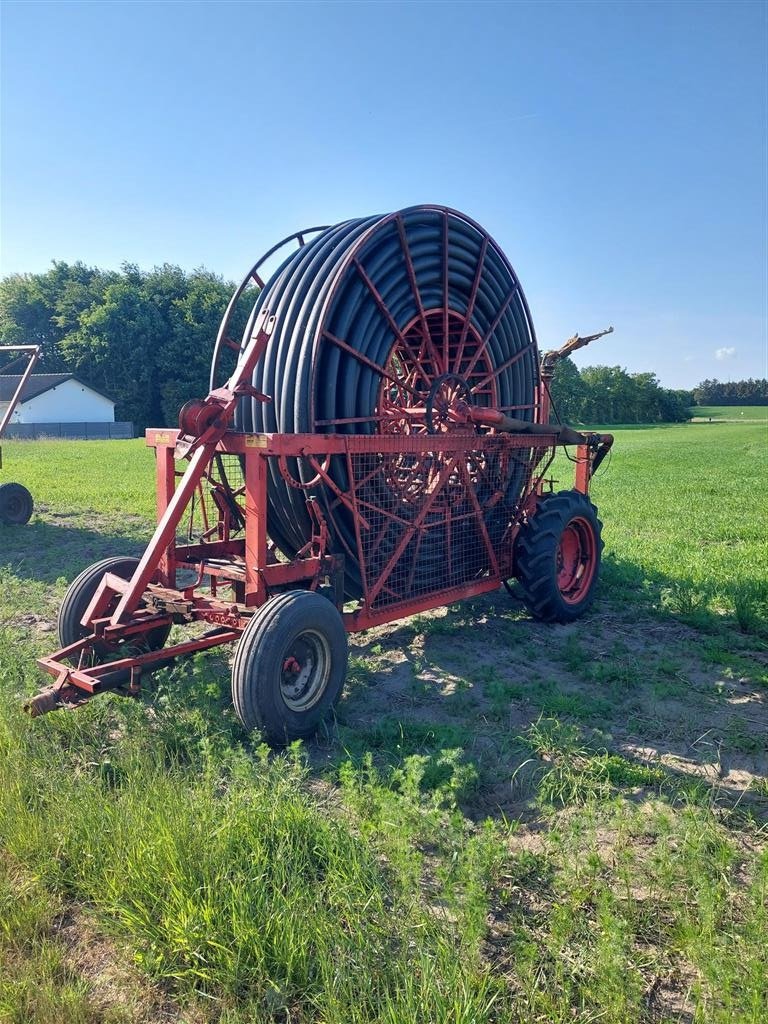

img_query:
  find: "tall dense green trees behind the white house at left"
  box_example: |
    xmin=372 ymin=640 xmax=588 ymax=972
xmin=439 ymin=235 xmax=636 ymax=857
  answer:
xmin=0 ymin=262 xmax=245 ymax=429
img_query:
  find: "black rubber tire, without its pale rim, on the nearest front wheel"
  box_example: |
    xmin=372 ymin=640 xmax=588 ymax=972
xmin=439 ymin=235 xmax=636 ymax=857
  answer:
xmin=232 ymin=590 xmax=348 ymax=746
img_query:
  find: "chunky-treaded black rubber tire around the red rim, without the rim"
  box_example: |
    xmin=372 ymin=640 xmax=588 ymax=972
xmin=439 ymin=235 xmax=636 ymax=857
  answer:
xmin=515 ymin=490 xmax=603 ymax=623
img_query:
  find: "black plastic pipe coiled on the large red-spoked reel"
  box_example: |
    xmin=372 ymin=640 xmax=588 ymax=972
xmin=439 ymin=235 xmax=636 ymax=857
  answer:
xmin=234 ymin=206 xmax=539 ymax=597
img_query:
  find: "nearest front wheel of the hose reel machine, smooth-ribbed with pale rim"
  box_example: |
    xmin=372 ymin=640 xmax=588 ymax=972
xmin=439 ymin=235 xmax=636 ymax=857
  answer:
xmin=232 ymin=590 xmax=347 ymax=746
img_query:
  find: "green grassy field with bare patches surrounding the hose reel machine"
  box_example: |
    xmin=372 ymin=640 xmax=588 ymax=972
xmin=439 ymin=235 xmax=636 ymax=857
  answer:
xmin=0 ymin=421 xmax=768 ymax=1024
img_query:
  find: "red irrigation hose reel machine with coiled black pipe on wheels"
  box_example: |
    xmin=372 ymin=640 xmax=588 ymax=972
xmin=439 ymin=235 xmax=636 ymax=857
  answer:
xmin=27 ymin=207 xmax=613 ymax=743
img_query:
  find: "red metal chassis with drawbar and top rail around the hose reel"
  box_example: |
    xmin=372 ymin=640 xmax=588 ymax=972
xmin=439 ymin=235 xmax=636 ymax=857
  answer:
xmin=33 ymin=430 xmax=608 ymax=703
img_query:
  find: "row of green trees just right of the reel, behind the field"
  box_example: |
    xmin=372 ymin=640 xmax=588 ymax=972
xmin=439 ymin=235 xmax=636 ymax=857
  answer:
xmin=551 ymin=359 xmax=693 ymax=423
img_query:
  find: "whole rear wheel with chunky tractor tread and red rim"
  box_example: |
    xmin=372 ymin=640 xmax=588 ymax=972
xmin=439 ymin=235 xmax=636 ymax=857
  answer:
xmin=515 ymin=490 xmax=603 ymax=623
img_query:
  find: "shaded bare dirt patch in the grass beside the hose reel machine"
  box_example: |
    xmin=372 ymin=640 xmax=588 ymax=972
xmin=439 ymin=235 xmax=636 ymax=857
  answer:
xmin=339 ymin=594 xmax=768 ymax=813
